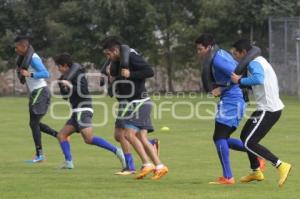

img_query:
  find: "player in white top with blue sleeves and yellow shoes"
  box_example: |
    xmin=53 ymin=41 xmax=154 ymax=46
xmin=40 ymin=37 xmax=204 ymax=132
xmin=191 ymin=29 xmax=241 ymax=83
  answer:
xmin=231 ymin=39 xmax=292 ymax=187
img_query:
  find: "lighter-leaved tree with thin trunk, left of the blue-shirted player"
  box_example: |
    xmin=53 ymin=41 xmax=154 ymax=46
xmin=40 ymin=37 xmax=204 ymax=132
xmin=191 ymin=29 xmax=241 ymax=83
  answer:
xmin=151 ymin=0 xmax=204 ymax=91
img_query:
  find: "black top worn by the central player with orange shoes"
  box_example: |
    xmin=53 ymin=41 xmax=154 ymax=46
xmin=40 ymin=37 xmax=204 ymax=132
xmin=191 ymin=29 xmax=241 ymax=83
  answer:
xmin=110 ymin=49 xmax=154 ymax=101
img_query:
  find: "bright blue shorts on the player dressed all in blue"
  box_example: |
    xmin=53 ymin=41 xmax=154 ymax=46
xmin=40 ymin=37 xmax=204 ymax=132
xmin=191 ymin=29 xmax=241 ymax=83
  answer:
xmin=216 ymin=99 xmax=246 ymax=128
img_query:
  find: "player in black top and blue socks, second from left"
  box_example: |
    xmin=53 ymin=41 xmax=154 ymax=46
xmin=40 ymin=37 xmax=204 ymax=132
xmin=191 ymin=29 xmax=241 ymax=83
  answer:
xmin=55 ymin=53 xmax=126 ymax=169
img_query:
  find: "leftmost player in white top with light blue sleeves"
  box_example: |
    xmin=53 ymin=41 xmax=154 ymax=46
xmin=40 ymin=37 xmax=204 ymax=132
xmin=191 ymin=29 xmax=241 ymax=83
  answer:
xmin=15 ymin=36 xmax=57 ymax=163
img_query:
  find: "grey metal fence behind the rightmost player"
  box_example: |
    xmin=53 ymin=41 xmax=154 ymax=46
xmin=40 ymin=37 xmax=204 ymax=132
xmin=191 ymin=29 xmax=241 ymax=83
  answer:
xmin=269 ymin=17 xmax=300 ymax=98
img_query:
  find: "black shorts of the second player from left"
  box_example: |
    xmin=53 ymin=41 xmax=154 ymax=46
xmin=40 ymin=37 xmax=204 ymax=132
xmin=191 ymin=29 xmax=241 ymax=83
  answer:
xmin=66 ymin=111 xmax=93 ymax=133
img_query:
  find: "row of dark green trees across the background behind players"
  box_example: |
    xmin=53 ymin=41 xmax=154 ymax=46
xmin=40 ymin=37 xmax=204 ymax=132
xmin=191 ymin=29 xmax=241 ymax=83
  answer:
xmin=0 ymin=0 xmax=300 ymax=91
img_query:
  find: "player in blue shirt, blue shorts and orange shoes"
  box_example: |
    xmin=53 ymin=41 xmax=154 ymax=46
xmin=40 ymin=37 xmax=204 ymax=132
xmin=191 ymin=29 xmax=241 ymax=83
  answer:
xmin=195 ymin=33 xmax=245 ymax=185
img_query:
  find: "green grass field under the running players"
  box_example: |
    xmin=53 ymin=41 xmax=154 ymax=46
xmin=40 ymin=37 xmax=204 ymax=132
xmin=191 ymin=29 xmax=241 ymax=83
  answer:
xmin=0 ymin=96 xmax=300 ymax=199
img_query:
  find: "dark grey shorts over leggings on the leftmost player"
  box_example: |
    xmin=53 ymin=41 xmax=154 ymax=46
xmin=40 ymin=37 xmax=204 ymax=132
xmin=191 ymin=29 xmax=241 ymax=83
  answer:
xmin=29 ymin=87 xmax=50 ymax=115
